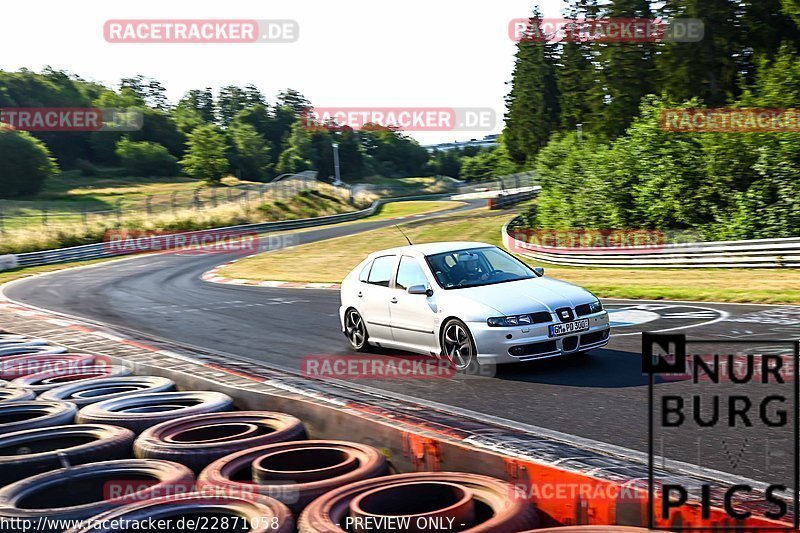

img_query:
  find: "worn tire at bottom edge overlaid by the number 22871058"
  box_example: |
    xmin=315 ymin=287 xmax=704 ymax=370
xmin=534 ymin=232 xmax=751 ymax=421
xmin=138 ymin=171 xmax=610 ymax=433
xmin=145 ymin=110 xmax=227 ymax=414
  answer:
xmin=65 ymin=493 xmax=295 ymax=533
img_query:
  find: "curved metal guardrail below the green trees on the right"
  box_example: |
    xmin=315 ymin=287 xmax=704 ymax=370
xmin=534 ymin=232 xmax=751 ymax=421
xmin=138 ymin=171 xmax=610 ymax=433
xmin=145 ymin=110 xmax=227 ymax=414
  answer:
xmin=502 ymin=215 xmax=800 ymax=268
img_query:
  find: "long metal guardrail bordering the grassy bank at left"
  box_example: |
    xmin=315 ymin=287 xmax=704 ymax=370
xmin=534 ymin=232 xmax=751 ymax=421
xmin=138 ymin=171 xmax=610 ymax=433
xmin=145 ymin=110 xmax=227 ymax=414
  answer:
xmin=0 ymin=194 xmax=449 ymax=271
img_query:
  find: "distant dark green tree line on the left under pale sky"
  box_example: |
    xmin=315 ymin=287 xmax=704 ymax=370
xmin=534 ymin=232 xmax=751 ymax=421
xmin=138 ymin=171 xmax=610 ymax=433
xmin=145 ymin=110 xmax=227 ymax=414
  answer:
xmin=0 ymin=68 xmax=496 ymax=197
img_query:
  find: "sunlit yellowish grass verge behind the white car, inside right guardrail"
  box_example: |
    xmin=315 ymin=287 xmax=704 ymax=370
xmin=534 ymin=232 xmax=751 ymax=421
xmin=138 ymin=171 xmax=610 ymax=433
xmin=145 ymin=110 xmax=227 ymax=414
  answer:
xmin=220 ymin=212 xmax=800 ymax=304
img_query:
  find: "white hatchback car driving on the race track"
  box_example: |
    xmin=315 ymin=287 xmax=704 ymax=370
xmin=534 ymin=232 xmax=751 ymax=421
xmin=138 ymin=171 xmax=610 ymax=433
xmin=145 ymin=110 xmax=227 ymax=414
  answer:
xmin=339 ymin=242 xmax=610 ymax=371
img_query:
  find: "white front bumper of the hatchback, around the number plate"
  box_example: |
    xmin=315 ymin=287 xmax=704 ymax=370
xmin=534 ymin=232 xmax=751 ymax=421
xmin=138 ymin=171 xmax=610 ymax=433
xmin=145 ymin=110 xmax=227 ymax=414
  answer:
xmin=467 ymin=311 xmax=611 ymax=364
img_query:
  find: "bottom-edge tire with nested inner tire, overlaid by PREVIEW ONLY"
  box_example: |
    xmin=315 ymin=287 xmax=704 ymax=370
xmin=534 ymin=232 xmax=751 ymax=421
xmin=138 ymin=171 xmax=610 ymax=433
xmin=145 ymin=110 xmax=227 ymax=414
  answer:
xmin=297 ymin=472 xmax=539 ymax=533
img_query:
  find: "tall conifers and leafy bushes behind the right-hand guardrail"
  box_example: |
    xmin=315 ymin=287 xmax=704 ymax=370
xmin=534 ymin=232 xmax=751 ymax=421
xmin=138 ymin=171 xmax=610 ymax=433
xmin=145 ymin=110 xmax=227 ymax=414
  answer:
xmin=501 ymin=0 xmax=800 ymax=239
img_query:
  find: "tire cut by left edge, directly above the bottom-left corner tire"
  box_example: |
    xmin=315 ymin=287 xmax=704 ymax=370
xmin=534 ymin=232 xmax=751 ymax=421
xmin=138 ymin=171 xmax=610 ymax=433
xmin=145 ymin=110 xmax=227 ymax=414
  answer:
xmin=0 ymin=424 xmax=135 ymax=486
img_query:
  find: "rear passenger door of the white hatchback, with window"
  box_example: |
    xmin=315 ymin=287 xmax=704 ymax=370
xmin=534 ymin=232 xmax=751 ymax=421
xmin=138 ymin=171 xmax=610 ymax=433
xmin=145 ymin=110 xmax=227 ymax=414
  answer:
xmin=356 ymin=255 xmax=397 ymax=342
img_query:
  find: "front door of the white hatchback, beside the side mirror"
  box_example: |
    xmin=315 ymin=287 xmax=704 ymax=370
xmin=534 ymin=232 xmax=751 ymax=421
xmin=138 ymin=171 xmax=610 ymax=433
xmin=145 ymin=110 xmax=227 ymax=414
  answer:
xmin=389 ymin=255 xmax=436 ymax=352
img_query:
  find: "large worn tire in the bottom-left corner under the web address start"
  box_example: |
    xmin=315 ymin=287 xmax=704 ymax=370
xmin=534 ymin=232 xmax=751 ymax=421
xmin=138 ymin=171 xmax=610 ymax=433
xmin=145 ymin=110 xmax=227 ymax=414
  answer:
xmin=0 ymin=459 xmax=194 ymax=533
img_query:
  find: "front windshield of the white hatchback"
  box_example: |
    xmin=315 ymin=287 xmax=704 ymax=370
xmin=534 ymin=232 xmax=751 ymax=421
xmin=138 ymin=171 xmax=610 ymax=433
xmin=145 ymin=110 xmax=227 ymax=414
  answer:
xmin=426 ymin=247 xmax=536 ymax=289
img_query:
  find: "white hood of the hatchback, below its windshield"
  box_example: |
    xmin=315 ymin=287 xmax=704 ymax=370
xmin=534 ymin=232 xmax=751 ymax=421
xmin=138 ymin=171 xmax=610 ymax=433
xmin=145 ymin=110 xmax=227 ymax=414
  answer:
xmin=453 ymin=277 xmax=596 ymax=316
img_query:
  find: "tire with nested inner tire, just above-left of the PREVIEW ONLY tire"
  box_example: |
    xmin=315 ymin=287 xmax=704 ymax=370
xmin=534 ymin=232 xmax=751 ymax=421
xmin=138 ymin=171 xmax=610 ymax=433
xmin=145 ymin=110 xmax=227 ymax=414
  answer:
xmin=197 ymin=440 xmax=388 ymax=512
